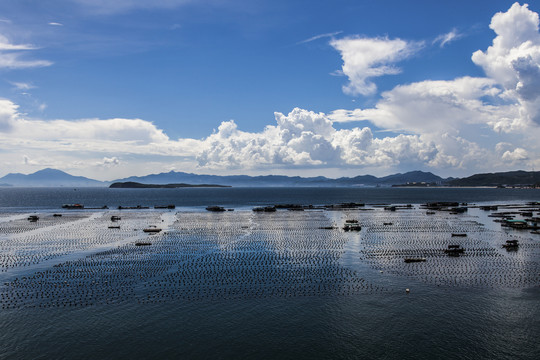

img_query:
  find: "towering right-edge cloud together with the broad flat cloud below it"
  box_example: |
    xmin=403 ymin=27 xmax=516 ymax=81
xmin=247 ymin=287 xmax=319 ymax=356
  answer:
xmin=331 ymin=3 xmax=540 ymax=139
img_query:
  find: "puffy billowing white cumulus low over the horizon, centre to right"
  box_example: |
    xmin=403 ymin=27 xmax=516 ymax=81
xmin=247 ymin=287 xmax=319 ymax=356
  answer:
xmin=197 ymin=108 xmax=488 ymax=169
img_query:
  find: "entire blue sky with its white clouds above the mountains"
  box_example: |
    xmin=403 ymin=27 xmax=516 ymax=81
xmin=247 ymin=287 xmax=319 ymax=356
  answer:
xmin=0 ymin=0 xmax=540 ymax=180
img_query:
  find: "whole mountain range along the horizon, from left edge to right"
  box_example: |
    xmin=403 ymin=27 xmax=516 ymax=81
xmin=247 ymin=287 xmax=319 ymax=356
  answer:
xmin=0 ymin=168 xmax=540 ymax=187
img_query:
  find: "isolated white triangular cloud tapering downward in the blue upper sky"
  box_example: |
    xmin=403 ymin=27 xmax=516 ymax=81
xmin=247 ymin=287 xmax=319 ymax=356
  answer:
xmin=330 ymin=37 xmax=419 ymax=95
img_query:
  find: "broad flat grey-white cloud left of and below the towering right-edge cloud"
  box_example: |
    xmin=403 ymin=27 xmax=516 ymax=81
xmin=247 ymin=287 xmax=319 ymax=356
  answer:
xmin=330 ymin=77 xmax=518 ymax=134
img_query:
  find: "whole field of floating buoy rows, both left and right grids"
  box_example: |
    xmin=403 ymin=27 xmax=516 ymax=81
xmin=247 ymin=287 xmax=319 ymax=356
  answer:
xmin=0 ymin=204 xmax=540 ymax=309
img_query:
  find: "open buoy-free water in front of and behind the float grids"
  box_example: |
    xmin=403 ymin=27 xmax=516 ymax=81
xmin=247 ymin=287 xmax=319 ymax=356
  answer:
xmin=0 ymin=188 xmax=540 ymax=359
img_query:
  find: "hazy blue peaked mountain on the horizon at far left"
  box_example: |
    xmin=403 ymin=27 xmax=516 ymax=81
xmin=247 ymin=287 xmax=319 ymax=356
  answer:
xmin=0 ymin=168 xmax=108 ymax=187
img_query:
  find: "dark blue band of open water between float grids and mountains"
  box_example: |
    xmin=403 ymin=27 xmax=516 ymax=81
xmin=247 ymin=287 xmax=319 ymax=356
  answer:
xmin=0 ymin=188 xmax=540 ymax=210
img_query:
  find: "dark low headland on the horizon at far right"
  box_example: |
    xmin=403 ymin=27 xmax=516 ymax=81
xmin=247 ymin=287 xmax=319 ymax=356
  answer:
xmin=449 ymin=171 xmax=540 ymax=186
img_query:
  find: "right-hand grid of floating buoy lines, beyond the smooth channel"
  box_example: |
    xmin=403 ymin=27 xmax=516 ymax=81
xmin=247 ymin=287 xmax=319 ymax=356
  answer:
xmin=360 ymin=209 xmax=540 ymax=288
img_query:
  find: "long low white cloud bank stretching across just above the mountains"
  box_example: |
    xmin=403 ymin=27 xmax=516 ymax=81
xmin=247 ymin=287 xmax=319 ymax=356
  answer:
xmin=0 ymin=95 xmax=531 ymax=177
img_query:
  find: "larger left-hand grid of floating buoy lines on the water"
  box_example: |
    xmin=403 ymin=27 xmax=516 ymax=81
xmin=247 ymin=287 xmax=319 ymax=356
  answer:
xmin=0 ymin=211 xmax=384 ymax=308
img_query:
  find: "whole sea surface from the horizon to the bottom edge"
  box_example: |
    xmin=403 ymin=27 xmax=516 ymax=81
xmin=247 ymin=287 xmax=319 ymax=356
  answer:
xmin=0 ymin=187 xmax=540 ymax=359
